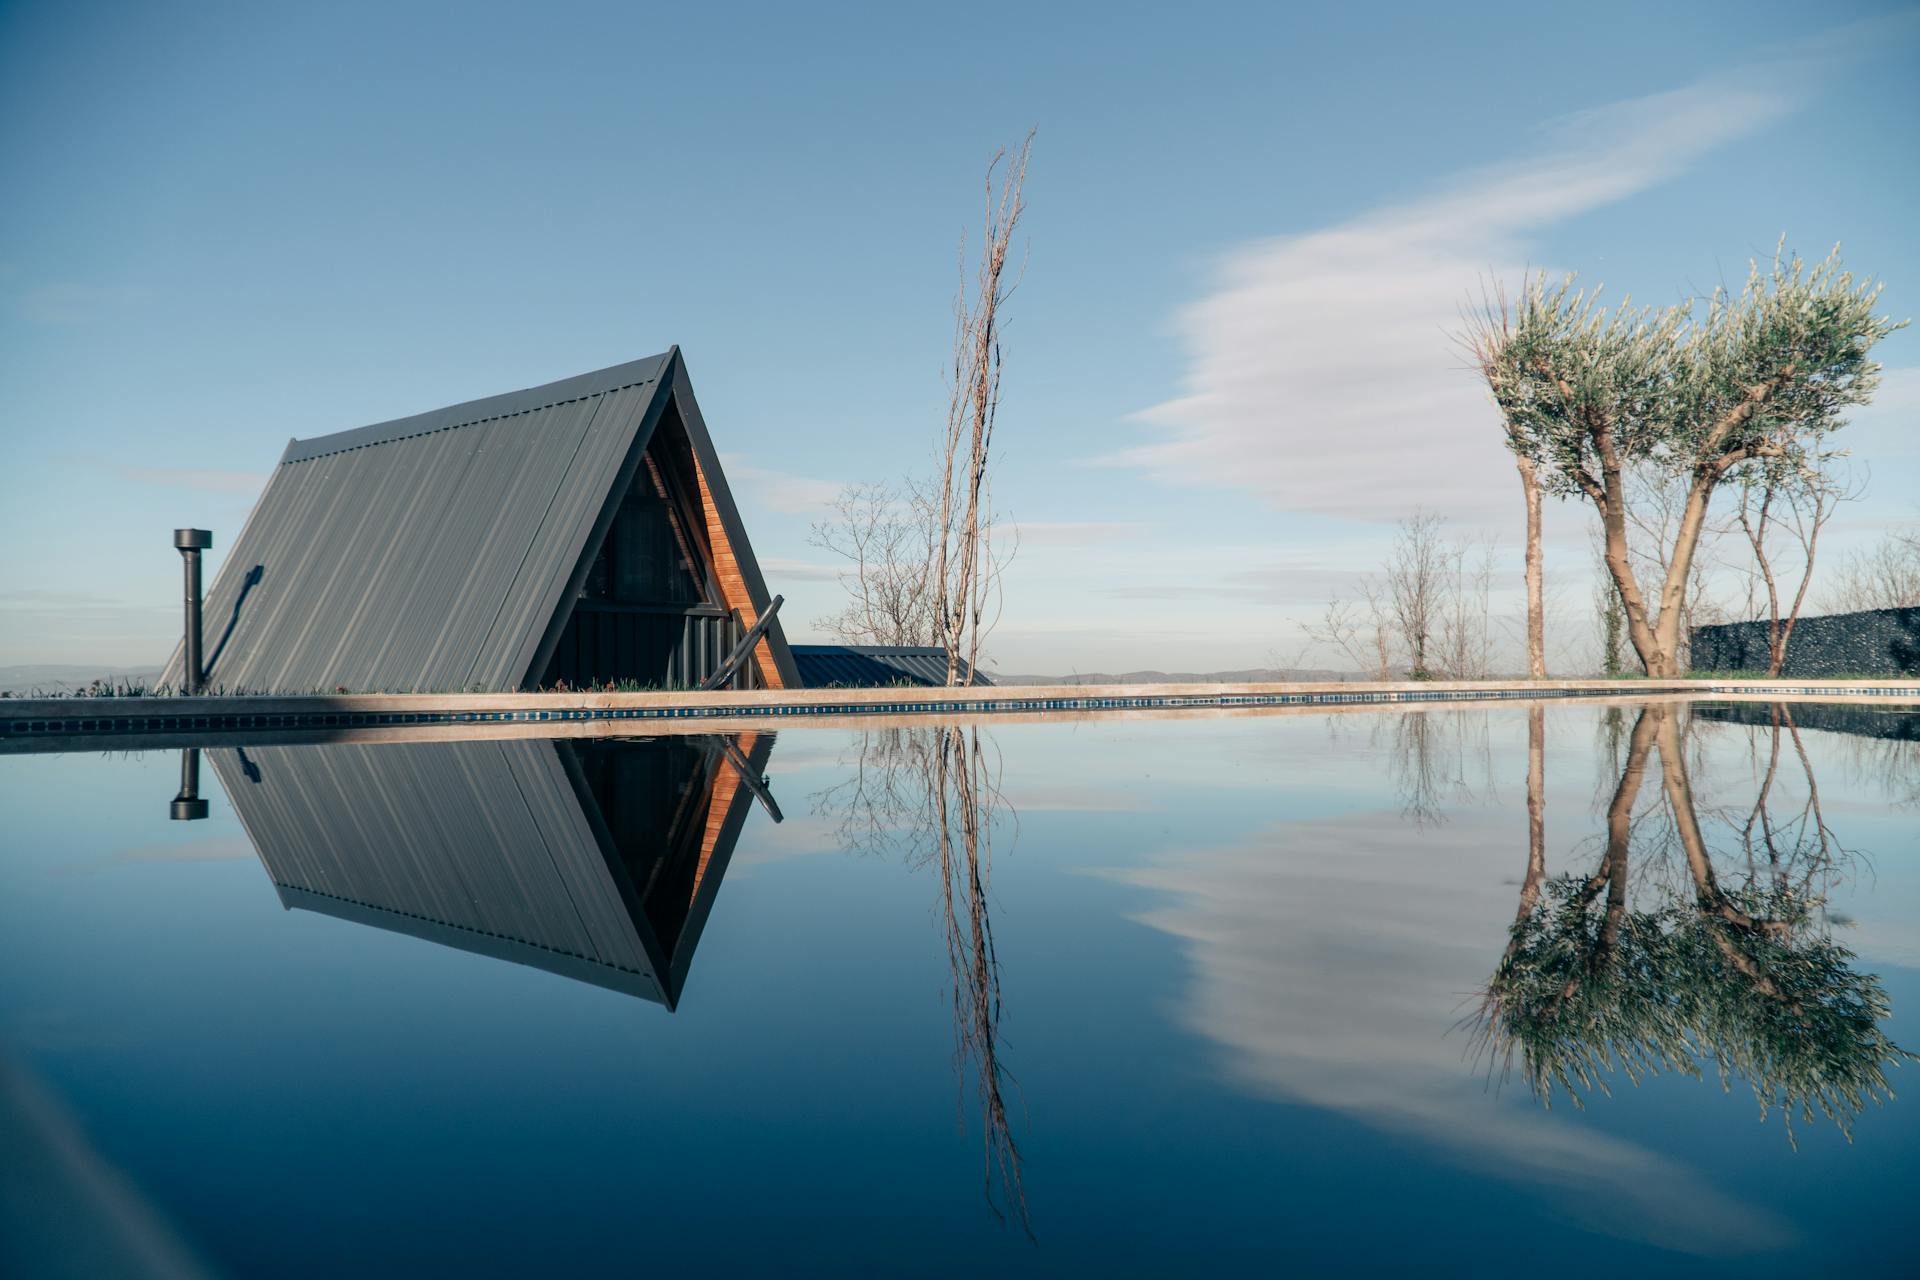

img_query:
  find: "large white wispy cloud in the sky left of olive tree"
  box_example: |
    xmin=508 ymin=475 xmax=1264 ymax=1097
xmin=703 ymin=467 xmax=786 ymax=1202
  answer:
xmin=1112 ymin=83 xmax=1791 ymax=520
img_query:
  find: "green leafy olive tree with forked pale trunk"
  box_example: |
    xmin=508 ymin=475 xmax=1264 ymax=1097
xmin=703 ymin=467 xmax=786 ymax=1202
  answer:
xmin=1488 ymin=251 xmax=1901 ymax=676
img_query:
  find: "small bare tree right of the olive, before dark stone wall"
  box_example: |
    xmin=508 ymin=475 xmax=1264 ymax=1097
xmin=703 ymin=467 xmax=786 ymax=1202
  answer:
xmin=1734 ymin=455 xmax=1859 ymax=676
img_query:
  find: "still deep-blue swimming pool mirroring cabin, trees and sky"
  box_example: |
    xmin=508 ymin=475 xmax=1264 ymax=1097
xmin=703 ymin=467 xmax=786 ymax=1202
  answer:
xmin=0 ymin=700 xmax=1920 ymax=1276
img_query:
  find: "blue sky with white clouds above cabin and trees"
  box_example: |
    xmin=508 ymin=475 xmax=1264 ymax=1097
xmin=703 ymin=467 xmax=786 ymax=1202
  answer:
xmin=0 ymin=2 xmax=1920 ymax=672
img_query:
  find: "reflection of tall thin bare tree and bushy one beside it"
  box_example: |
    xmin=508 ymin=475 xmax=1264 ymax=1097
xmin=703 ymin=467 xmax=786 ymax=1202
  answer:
xmin=814 ymin=723 xmax=1033 ymax=1238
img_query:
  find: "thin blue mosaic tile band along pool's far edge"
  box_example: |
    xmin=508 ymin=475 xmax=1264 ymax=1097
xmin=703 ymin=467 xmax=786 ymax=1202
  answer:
xmin=15 ymin=681 xmax=1916 ymax=735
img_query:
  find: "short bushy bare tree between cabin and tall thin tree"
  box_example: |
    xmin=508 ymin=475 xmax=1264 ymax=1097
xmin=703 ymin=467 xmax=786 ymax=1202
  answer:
xmin=806 ymin=480 xmax=941 ymax=645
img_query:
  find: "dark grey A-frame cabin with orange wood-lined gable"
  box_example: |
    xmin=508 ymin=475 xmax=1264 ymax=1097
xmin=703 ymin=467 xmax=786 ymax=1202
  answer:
xmin=161 ymin=347 xmax=801 ymax=693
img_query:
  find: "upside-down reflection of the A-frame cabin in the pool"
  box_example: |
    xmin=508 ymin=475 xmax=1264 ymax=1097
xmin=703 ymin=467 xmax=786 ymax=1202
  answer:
xmin=209 ymin=735 xmax=778 ymax=1007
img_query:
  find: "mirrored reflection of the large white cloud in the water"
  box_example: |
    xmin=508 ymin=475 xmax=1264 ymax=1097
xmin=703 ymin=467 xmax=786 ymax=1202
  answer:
xmin=1119 ymin=812 xmax=1793 ymax=1253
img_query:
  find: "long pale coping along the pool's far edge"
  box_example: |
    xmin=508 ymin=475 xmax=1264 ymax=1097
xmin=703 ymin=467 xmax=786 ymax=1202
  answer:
xmin=0 ymin=679 xmax=1920 ymax=752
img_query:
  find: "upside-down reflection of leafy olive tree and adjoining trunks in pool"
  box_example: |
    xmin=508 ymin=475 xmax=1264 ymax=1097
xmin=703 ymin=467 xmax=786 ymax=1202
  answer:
xmin=1475 ymin=706 xmax=1912 ymax=1140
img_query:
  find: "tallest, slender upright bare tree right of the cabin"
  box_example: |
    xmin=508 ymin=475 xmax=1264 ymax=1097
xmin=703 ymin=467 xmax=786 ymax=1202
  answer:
xmin=933 ymin=130 xmax=1033 ymax=685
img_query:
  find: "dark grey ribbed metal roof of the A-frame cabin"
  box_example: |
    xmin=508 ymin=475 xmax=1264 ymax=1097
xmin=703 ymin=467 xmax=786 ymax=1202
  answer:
xmin=161 ymin=347 xmax=799 ymax=693
